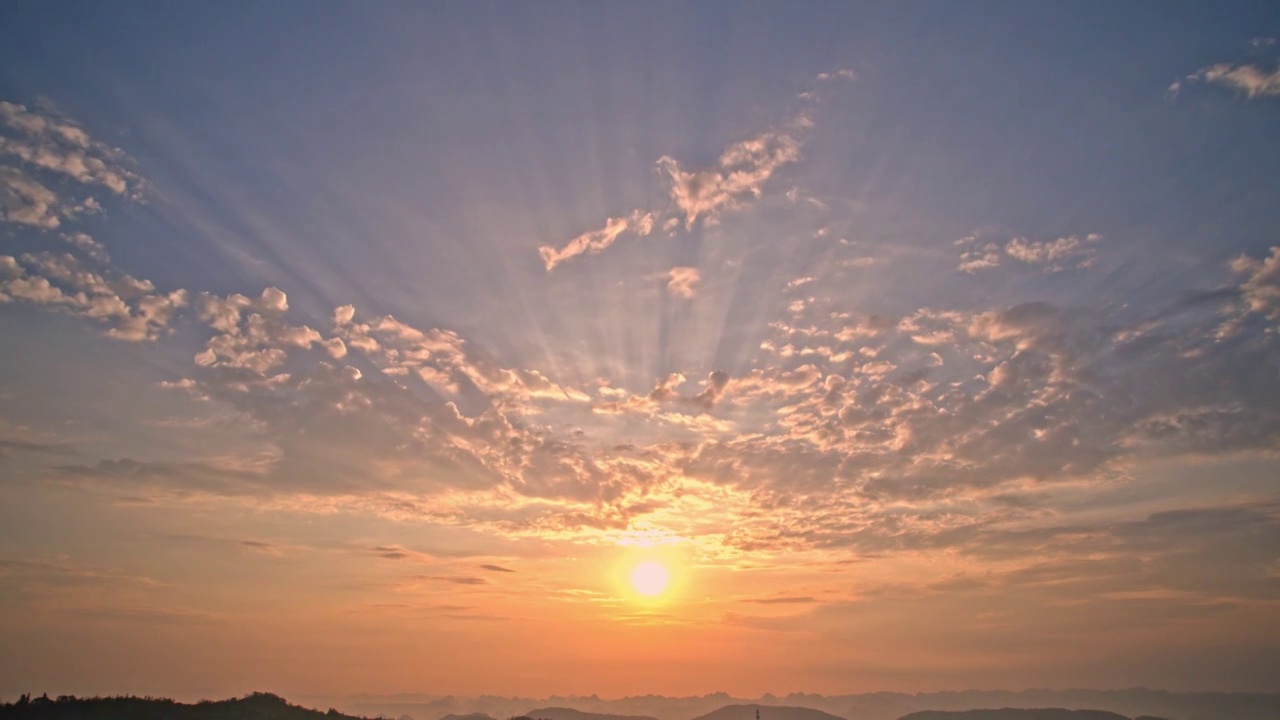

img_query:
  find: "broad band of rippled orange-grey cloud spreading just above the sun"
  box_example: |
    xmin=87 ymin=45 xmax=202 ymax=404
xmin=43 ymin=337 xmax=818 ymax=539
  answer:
xmin=20 ymin=222 xmax=1280 ymax=556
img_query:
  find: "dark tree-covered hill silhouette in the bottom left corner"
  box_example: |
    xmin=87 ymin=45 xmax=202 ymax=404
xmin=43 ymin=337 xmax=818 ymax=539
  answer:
xmin=0 ymin=693 xmax=364 ymax=720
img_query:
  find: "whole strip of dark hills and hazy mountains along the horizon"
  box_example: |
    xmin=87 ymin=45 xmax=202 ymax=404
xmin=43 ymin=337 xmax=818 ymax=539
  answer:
xmin=0 ymin=689 xmax=1280 ymax=720
